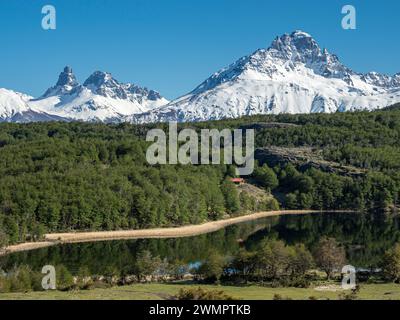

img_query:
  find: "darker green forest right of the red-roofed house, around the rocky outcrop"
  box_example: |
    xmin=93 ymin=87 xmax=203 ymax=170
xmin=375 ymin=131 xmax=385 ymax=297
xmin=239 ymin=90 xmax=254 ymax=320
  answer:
xmin=202 ymin=105 xmax=400 ymax=212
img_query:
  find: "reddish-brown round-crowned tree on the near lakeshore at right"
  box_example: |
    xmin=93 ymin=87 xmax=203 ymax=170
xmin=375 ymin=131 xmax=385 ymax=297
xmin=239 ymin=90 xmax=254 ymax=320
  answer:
xmin=314 ymin=238 xmax=346 ymax=279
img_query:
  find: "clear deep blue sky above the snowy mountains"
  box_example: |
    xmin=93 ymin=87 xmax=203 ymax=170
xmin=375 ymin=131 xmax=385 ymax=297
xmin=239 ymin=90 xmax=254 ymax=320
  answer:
xmin=0 ymin=0 xmax=400 ymax=99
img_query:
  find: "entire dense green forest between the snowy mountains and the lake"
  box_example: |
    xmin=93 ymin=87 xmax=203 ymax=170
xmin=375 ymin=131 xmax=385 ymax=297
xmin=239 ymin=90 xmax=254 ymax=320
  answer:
xmin=0 ymin=107 xmax=400 ymax=245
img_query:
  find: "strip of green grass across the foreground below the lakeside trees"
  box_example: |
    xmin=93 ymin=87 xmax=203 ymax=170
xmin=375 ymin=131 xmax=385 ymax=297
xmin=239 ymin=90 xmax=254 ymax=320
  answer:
xmin=0 ymin=284 xmax=400 ymax=300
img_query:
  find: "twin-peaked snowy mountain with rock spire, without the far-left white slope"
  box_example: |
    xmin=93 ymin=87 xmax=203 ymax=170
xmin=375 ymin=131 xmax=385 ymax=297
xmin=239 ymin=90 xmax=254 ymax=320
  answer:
xmin=28 ymin=67 xmax=168 ymax=121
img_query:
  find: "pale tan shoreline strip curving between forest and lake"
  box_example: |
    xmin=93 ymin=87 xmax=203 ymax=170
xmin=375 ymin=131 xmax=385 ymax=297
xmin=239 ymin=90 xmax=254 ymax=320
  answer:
xmin=0 ymin=210 xmax=355 ymax=256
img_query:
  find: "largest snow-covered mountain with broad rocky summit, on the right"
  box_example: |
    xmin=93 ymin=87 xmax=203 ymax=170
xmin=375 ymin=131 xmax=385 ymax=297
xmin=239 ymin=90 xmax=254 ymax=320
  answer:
xmin=131 ymin=31 xmax=400 ymax=123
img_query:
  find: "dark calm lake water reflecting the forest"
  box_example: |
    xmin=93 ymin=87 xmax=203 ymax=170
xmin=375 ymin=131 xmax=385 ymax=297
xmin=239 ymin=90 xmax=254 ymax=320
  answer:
xmin=0 ymin=213 xmax=400 ymax=274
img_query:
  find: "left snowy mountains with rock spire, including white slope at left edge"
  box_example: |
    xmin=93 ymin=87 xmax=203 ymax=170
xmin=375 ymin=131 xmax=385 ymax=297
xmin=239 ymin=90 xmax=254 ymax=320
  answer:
xmin=0 ymin=67 xmax=168 ymax=122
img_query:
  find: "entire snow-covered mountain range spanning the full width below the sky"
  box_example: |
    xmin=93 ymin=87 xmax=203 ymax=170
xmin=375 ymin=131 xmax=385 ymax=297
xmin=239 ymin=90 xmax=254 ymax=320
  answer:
xmin=0 ymin=31 xmax=400 ymax=123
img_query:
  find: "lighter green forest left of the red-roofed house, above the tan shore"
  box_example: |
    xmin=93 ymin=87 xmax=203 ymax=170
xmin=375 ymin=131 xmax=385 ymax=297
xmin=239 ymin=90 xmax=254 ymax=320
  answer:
xmin=0 ymin=123 xmax=277 ymax=243
